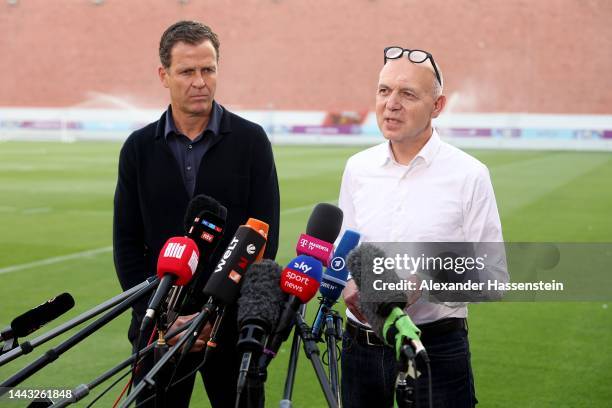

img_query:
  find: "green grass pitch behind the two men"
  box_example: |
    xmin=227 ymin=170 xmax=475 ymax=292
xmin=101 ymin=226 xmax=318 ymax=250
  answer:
xmin=0 ymin=142 xmax=612 ymax=407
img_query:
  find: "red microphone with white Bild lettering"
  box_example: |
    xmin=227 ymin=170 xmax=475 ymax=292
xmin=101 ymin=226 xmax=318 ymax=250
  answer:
xmin=140 ymin=237 xmax=200 ymax=333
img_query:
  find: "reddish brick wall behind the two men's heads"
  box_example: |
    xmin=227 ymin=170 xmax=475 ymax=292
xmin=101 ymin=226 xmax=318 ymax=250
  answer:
xmin=0 ymin=0 xmax=612 ymax=114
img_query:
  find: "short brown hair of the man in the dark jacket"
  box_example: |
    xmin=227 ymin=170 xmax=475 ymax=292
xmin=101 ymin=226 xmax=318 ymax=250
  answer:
xmin=159 ymin=20 xmax=220 ymax=68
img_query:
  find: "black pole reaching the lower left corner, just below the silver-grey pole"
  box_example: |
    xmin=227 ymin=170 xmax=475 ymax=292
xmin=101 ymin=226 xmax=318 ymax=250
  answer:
xmin=0 ymin=280 xmax=159 ymax=396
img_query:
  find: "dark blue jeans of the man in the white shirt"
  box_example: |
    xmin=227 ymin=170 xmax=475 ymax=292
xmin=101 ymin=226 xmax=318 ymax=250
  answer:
xmin=341 ymin=330 xmax=478 ymax=408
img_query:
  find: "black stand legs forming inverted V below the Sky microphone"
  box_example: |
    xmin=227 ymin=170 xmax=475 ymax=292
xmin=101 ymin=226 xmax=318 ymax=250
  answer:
xmin=280 ymin=305 xmax=338 ymax=408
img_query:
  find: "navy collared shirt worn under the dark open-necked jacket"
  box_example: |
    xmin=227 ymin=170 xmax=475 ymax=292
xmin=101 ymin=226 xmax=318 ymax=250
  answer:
xmin=164 ymin=101 xmax=223 ymax=197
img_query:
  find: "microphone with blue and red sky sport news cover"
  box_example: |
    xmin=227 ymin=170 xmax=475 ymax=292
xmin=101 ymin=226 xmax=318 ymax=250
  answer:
xmin=263 ymin=255 xmax=323 ymax=360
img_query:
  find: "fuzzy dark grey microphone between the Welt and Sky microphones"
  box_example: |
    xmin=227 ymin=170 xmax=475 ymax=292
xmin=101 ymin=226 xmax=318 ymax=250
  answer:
xmin=236 ymin=259 xmax=287 ymax=399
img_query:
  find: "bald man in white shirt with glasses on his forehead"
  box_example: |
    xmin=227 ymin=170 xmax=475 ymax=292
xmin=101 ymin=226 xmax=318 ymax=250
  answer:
xmin=339 ymin=47 xmax=503 ymax=408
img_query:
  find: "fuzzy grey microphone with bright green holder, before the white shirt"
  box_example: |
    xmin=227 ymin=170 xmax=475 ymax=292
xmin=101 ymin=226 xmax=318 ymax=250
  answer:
xmin=347 ymin=243 xmax=429 ymax=361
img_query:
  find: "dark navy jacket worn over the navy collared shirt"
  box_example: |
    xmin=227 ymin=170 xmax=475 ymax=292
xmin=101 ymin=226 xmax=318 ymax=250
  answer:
xmin=113 ymin=109 xmax=280 ymax=340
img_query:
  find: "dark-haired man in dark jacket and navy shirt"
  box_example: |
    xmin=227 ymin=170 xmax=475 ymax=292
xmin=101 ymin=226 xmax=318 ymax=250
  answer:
xmin=113 ymin=21 xmax=280 ymax=407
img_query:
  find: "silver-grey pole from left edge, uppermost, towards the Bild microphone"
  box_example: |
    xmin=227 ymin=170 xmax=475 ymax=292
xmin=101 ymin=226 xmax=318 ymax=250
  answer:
xmin=0 ymin=277 xmax=157 ymax=367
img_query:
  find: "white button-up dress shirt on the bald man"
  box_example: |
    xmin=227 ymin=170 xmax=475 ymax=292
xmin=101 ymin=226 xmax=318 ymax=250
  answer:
xmin=339 ymin=130 xmax=503 ymax=324
